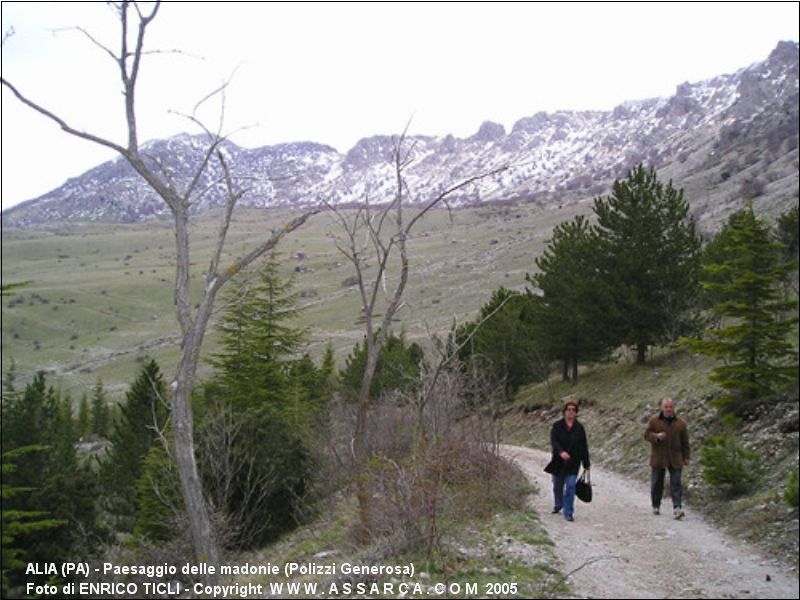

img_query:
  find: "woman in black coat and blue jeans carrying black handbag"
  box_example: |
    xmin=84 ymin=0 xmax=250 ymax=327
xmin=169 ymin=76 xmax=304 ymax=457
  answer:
xmin=545 ymin=399 xmax=589 ymax=521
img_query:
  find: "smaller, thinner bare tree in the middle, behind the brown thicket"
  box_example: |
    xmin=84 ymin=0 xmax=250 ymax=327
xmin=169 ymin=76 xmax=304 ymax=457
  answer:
xmin=328 ymin=127 xmax=508 ymax=536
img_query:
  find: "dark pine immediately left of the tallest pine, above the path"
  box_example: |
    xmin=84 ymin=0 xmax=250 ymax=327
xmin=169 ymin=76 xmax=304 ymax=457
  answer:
xmin=526 ymin=216 xmax=615 ymax=384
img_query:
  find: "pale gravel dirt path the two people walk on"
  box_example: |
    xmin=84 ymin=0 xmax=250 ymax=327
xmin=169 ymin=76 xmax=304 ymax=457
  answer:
xmin=502 ymin=446 xmax=800 ymax=598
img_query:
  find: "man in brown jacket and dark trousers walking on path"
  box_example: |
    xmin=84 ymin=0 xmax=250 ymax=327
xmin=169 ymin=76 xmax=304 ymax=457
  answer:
xmin=644 ymin=398 xmax=690 ymax=519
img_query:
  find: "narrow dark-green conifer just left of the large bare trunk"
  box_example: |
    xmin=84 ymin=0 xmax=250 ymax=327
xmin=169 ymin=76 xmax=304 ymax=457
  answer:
xmin=100 ymin=360 xmax=169 ymax=530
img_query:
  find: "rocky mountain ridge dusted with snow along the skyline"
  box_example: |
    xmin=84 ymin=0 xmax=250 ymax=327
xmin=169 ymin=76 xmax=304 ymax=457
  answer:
xmin=3 ymin=42 xmax=800 ymax=228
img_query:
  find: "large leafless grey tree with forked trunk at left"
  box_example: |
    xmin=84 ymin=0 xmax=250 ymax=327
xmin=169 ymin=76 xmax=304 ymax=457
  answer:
xmin=2 ymin=1 xmax=318 ymax=563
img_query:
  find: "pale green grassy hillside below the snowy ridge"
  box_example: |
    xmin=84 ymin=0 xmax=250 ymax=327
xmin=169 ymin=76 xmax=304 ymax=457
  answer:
xmin=2 ymin=202 xmax=589 ymax=396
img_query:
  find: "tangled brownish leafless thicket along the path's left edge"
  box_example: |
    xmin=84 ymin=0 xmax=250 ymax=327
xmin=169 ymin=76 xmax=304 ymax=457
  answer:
xmin=361 ymin=356 xmax=524 ymax=553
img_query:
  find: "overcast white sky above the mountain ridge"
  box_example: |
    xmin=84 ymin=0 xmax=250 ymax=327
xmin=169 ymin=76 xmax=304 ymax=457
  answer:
xmin=2 ymin=2 xmax=800 ymax=209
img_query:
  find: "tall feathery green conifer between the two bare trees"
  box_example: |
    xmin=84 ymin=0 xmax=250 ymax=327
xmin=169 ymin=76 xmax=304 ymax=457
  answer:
xmin=197 ymin=259 xmax=322 ymax=547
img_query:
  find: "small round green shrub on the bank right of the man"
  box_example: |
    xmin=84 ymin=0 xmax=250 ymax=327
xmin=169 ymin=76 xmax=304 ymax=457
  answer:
xmin=700 ymin=434 xmax=759 ymax=497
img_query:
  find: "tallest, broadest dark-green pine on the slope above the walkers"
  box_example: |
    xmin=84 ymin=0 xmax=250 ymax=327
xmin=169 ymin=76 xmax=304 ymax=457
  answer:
xmin=594 ymin=165 xmax=700 ymax=364
